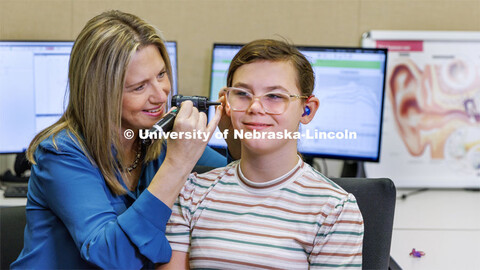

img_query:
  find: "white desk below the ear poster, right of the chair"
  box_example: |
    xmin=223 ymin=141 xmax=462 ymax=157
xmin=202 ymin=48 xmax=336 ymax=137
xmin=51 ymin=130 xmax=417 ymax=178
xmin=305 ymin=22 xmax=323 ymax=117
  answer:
xmin=390 ymin=189 xmax=480 ymax=270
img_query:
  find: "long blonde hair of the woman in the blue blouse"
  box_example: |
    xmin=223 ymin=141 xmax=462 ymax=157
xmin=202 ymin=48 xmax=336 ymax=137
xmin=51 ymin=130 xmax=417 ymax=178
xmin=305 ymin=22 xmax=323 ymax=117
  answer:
xmin=27 ymin=10 xmax=172 ymax=194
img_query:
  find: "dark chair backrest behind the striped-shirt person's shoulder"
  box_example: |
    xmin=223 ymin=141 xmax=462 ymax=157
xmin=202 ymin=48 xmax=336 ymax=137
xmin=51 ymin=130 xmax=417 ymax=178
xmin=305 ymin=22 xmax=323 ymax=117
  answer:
xmin=331 ymin=178 xmax=396 ymax=269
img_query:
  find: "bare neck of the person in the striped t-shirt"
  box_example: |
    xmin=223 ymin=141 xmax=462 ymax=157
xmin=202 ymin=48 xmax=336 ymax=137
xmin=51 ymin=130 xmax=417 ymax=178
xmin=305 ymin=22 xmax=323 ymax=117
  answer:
xmin=240 ymin=143 xmax=298 ymax=182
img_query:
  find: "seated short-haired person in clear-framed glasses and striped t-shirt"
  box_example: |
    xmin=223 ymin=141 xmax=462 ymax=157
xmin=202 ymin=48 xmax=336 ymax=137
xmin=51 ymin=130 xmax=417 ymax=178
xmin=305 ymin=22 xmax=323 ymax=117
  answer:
xmin=160 ymin=40 xmax=363 ymax=269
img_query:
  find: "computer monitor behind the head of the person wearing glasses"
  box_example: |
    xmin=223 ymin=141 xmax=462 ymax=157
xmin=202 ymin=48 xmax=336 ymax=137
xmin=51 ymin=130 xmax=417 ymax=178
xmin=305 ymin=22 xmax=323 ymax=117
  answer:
xmin=209 ymin=44 xmax=387 ymax=162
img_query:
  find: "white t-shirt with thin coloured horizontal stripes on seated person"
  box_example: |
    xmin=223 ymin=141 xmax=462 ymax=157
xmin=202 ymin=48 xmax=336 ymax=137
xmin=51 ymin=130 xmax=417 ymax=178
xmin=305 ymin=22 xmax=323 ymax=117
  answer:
xmin=166 ymin=160 xmax=363 ymax=269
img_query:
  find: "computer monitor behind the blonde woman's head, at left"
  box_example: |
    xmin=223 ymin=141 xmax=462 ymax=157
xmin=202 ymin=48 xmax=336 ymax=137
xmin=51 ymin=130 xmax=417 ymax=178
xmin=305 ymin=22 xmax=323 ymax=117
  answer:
xmin=0 ymin=41 xmax=177 ymax=154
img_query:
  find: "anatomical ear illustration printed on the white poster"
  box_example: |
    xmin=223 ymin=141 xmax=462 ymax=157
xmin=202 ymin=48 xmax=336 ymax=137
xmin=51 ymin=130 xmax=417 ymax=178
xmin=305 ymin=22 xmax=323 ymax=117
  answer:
xmin=387 ymin=59 xmax=480 ymax=168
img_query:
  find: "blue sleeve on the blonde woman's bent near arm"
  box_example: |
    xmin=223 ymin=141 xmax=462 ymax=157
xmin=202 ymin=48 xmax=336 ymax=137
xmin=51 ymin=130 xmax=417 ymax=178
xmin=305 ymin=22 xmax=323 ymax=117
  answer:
xmin=36 ymin=142 xmax=171 ymax=269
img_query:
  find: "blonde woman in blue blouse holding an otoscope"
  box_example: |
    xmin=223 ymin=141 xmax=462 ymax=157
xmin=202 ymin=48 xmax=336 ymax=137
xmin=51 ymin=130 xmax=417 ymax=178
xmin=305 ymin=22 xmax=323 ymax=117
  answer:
xmin=11 ymin=11 xmax=226 ymax=269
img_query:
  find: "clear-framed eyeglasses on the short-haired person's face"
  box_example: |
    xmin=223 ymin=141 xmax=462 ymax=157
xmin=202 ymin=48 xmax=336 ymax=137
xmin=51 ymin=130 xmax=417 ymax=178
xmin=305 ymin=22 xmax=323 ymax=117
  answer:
xmin=226 ymin=87 xmax=308 ymax=114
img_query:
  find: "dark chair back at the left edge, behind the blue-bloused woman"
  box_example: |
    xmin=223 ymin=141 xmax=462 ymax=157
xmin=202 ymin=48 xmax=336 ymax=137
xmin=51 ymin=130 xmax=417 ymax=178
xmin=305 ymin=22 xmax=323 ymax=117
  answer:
xmin=0 ymin=206 xmax=27 ymax=269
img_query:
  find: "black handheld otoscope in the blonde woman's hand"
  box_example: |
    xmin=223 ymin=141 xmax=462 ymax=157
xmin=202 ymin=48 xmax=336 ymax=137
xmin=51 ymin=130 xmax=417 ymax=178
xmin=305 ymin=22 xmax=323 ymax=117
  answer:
xmin=142 ymin=95 xmax=222 ymax=145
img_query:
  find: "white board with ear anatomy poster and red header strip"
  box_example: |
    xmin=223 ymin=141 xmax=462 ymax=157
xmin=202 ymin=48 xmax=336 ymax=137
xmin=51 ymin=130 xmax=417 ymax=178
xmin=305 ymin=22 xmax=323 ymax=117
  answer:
xmin=362 ymin=31 xmax=480 ymax=188
